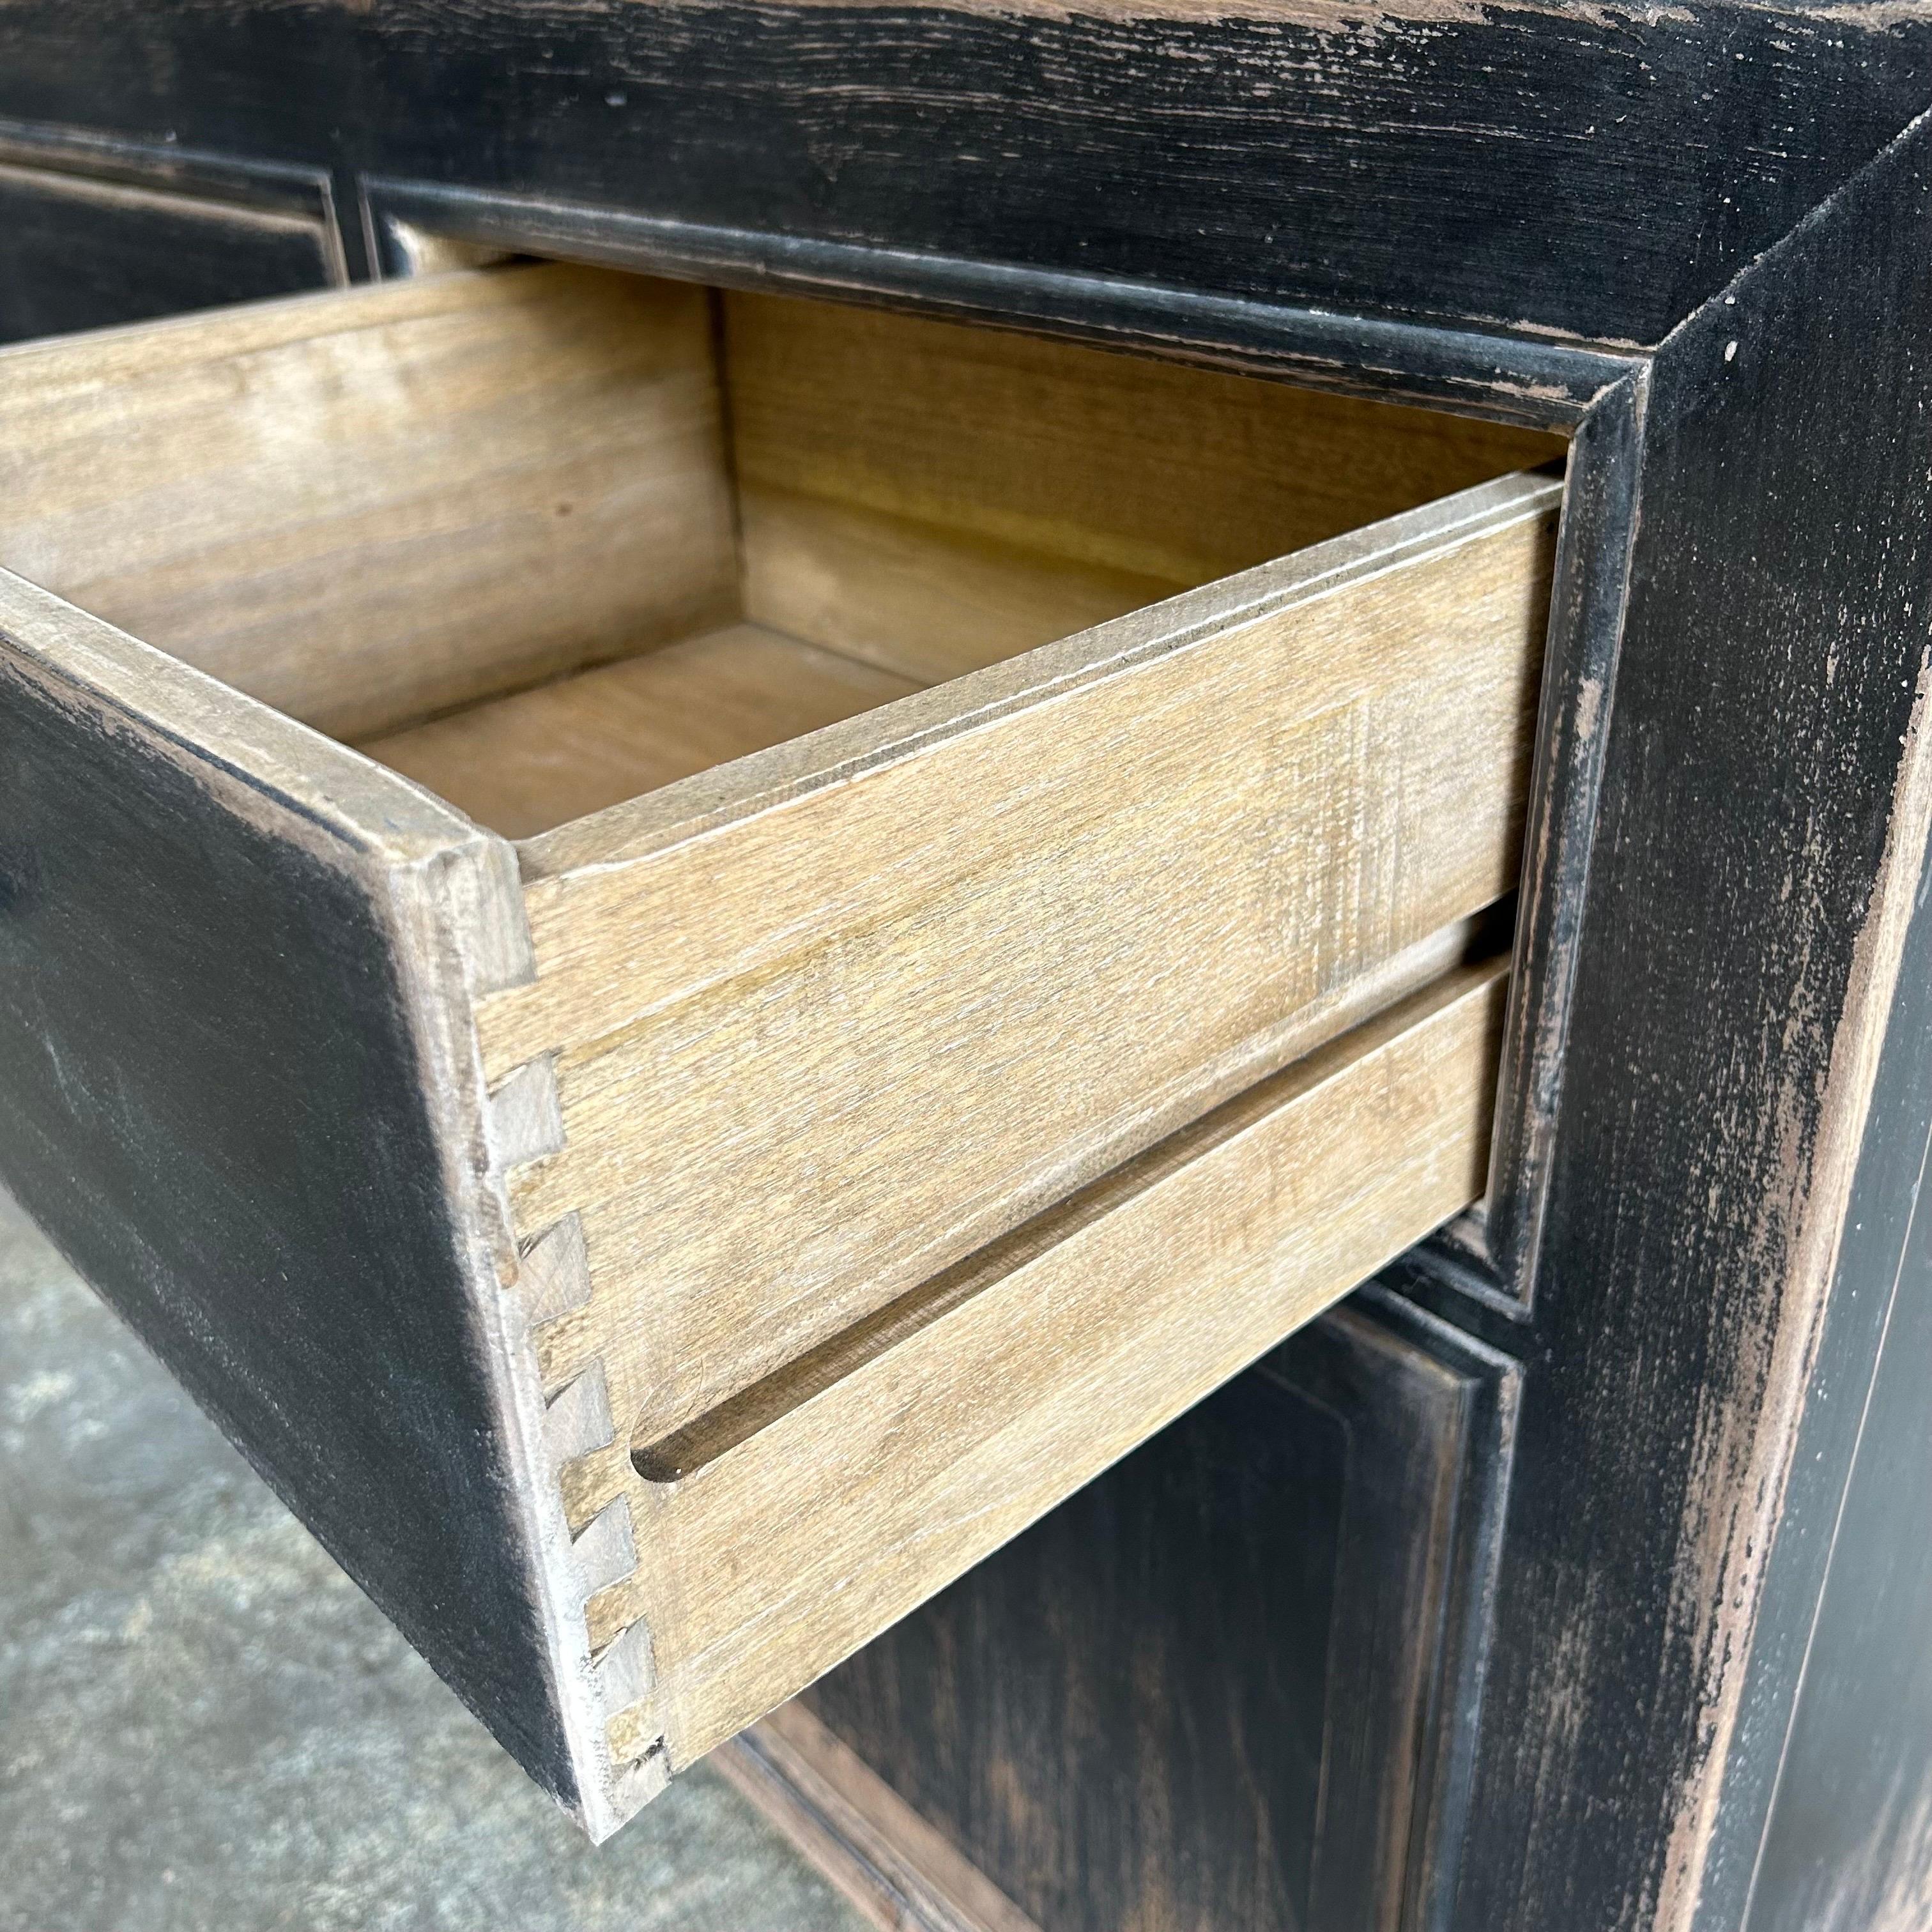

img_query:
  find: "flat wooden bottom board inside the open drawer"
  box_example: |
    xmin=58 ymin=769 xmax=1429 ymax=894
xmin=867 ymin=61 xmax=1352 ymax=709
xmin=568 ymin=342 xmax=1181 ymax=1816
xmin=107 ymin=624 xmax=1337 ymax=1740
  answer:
xmin=364 ymin=624 xmax=916 ymax=838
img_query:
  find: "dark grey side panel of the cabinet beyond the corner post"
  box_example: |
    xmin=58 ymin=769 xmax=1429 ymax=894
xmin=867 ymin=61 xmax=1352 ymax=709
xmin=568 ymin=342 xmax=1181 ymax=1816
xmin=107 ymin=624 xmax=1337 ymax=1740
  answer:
xmin=1700 ymin=827 xmax=1932 ymax=1932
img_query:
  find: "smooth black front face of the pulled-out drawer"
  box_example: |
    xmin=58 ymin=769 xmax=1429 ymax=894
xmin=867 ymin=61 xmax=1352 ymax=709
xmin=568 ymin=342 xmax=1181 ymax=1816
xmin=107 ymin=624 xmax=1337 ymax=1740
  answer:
xmin=0 ymin=668 xmax=576 ymax=1800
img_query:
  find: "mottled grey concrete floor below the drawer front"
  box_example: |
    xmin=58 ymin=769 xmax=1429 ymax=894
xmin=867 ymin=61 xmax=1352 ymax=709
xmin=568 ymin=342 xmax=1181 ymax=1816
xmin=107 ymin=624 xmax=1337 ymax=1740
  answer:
xmin=0 ymin=1196 xmax=860 ymax=1932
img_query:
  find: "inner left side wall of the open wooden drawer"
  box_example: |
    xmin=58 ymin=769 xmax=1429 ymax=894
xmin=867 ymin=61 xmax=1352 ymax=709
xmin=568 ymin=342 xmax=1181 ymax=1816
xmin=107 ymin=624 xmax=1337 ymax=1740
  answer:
xmin=0 ymin=266 xmax=736 ymax=736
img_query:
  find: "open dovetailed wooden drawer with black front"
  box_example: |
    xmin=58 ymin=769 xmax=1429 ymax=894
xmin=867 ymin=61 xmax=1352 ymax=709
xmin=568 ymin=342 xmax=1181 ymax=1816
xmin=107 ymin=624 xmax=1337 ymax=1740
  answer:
xmin=0 ymin=266 xmax=1561 ymax=1836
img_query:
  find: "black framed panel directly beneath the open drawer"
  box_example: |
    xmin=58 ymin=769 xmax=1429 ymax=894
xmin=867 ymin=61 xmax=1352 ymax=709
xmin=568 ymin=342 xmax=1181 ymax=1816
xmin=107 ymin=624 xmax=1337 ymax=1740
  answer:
xmin=808 ymin=1296 xmax=1515 ymax=1932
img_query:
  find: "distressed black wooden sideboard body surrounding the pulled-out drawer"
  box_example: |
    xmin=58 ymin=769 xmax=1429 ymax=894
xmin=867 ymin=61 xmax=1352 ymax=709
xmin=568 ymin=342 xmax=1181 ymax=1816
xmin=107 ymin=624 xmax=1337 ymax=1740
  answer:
xmin=0 ymin=0 xmax=1932 ymax=1932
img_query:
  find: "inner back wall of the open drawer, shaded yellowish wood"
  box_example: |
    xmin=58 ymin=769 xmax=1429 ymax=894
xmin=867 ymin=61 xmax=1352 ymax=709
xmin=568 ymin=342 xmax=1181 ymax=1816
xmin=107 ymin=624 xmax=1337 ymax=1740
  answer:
xmin=723 ymin=282 xmax=1563 ymax=682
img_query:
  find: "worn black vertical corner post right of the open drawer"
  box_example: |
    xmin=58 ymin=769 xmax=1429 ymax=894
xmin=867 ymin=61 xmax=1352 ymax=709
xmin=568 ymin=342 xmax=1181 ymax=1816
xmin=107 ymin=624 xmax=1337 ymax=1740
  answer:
xmin=1460 ymin=109 xmax=1932 ymax=1932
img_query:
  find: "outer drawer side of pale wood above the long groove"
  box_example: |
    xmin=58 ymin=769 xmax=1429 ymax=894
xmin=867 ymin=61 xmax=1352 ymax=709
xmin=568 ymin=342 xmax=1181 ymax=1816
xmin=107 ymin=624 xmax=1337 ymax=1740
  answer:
xmin=479 ymin=479 xmax=1557 ymax=1430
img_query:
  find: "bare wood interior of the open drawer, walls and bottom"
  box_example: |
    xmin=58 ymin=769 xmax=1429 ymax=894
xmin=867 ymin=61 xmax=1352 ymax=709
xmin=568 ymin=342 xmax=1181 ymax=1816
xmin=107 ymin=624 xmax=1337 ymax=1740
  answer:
xmin=0 ymin=264 xmax=1561 ymax=838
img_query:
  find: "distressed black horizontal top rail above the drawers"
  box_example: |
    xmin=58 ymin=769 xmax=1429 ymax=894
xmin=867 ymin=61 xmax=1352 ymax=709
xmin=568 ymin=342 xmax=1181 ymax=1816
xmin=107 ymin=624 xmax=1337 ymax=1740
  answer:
xmin=0 ymin=0 xmax=1932 ymax=344
